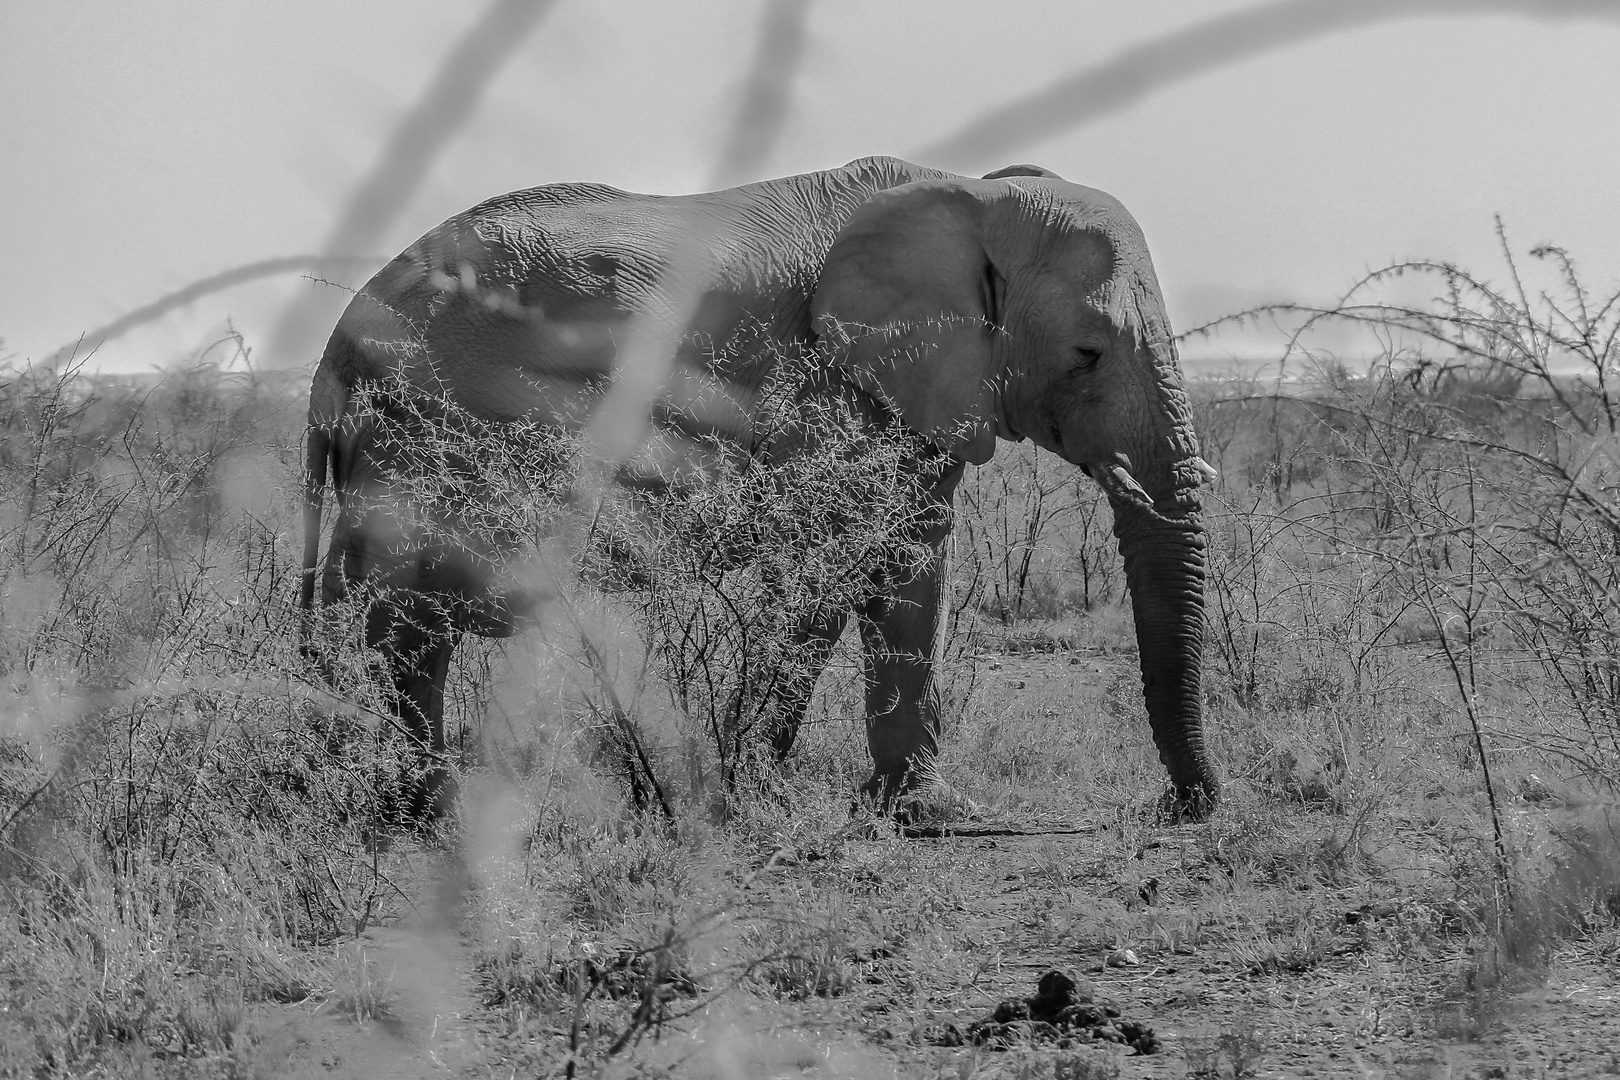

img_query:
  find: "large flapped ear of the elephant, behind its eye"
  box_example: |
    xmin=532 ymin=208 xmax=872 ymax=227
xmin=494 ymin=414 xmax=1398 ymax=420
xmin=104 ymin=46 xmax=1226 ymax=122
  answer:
xmin=812 ymin=180 xmax=1004 ymax=465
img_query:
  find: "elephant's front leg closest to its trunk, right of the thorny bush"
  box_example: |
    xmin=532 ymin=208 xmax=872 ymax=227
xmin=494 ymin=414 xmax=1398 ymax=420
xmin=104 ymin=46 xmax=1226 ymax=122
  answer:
xmin=860 ymin=541 xmax=944 ymax=803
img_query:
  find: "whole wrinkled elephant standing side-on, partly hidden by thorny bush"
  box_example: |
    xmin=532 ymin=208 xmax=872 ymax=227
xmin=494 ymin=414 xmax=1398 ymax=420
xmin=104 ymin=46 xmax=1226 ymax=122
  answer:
xmin=301 ymin=157 xmax=1220 ymax=819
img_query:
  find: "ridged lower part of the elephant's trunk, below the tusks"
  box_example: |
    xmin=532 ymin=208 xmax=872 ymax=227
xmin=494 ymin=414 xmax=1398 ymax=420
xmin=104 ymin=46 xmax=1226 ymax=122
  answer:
xmin=1115 ymin=492 xmax=1220 ymax=819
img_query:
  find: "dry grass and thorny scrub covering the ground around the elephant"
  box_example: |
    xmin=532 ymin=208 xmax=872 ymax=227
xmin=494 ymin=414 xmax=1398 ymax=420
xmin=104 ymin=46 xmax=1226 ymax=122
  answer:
xmin=0 ymin=241 xmax=1620 ymax=1077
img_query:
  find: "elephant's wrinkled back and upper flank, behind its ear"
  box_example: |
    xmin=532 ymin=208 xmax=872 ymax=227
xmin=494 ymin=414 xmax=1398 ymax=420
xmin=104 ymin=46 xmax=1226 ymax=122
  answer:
xmin=311 ymin=159 xmax=935 ymax=443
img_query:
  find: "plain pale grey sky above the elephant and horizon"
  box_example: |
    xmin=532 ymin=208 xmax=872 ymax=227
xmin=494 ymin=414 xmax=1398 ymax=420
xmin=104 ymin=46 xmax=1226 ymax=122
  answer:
xmin=0 ymin=0 xmax=1620 ymax=368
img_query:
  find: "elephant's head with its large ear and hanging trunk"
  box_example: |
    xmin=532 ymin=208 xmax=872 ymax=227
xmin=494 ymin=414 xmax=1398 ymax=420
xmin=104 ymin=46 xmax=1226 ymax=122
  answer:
xmin=813 ymin=167 xmax=1218 ymax=816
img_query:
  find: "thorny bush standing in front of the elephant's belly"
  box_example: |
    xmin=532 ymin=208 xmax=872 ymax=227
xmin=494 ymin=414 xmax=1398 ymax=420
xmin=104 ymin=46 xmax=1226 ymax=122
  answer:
xmin=352 ymin=338 xmax=944 ymax=818
